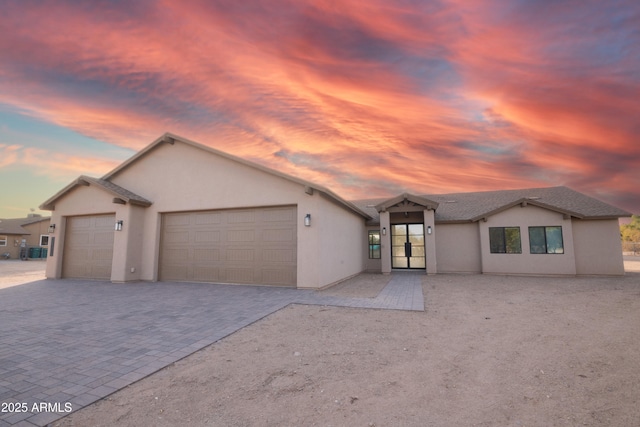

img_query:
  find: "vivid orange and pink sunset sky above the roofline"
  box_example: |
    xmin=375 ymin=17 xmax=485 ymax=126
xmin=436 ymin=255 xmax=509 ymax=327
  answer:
xmin=0 ymin=0 xmax=640 ymax=218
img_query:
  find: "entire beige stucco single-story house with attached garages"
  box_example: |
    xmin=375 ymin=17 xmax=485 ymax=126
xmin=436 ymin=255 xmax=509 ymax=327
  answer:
xmin=41 ymin=134 xmax=630 ymax=289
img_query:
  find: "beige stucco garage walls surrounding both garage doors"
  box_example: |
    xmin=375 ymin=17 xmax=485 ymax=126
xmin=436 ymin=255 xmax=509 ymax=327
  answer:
xmin=47 ymin=141 xmax=365 ymax=288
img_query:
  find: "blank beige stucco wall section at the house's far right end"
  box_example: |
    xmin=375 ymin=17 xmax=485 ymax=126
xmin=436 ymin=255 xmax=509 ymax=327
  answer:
xmin=572 ymin=219 xmax=624 ymax=275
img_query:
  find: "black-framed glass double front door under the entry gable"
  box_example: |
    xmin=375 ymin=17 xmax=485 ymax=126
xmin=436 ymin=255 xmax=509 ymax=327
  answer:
xmin=391 ymin=224 xmax=426 ymax=269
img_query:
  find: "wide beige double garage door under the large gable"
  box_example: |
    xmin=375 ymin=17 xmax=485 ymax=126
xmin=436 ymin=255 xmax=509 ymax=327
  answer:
xmin=159 ymin=206 xmax=297 ymax=286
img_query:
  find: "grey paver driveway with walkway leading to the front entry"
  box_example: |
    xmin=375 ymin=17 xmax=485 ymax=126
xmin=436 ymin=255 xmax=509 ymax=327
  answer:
xmin=0 ymin=273 xmax=424 ymax=427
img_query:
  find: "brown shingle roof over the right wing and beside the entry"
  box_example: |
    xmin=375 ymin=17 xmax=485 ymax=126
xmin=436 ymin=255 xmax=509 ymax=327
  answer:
xmin=353 ymin=187 xmax=631 ymax=224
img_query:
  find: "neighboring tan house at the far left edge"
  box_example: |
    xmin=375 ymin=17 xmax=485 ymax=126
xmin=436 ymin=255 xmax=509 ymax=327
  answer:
xmin=0 ymin=214 xmax=50 ymax=260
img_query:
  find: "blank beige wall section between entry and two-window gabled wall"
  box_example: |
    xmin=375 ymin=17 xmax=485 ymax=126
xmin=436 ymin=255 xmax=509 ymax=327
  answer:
xmin=436 ymin=222 xmax=482 ymax=273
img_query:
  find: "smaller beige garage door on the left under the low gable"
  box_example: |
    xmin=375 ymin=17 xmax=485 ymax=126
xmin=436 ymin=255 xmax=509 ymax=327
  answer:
xmin=62 ymin=215 xmax=115 ymax=280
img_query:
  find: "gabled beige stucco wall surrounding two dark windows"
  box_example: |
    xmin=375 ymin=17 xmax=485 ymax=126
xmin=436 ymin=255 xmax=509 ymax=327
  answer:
xmin=478 ymin=205 xmax=576 ymax=275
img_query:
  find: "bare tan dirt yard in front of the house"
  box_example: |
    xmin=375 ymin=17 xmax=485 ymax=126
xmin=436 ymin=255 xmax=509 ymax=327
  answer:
xmin=5 ymin=258 xmax=640 ymax=426
